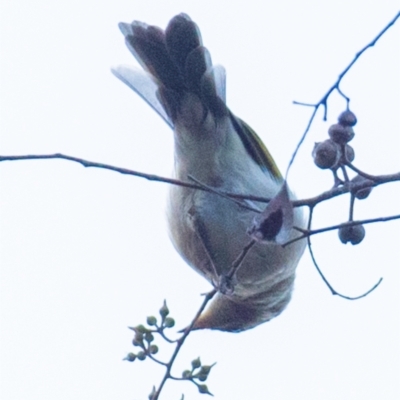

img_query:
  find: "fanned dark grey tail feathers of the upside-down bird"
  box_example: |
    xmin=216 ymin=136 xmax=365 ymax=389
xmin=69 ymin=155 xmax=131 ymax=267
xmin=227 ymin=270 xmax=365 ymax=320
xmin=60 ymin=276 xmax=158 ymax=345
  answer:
xmin=113 ymin=14 xmax=228 ymax=126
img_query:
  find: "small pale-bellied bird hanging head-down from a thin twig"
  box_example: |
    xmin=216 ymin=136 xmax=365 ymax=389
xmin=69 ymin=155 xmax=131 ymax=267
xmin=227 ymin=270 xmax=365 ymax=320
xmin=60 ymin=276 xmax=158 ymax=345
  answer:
xmin=112 ymin=13 xmax=305 ymax=332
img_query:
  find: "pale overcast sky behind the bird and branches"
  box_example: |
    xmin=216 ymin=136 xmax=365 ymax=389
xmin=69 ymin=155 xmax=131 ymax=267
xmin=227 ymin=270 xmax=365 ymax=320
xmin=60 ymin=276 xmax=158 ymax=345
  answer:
xmin=0 ymin=0 xmax=400 ymax=400
